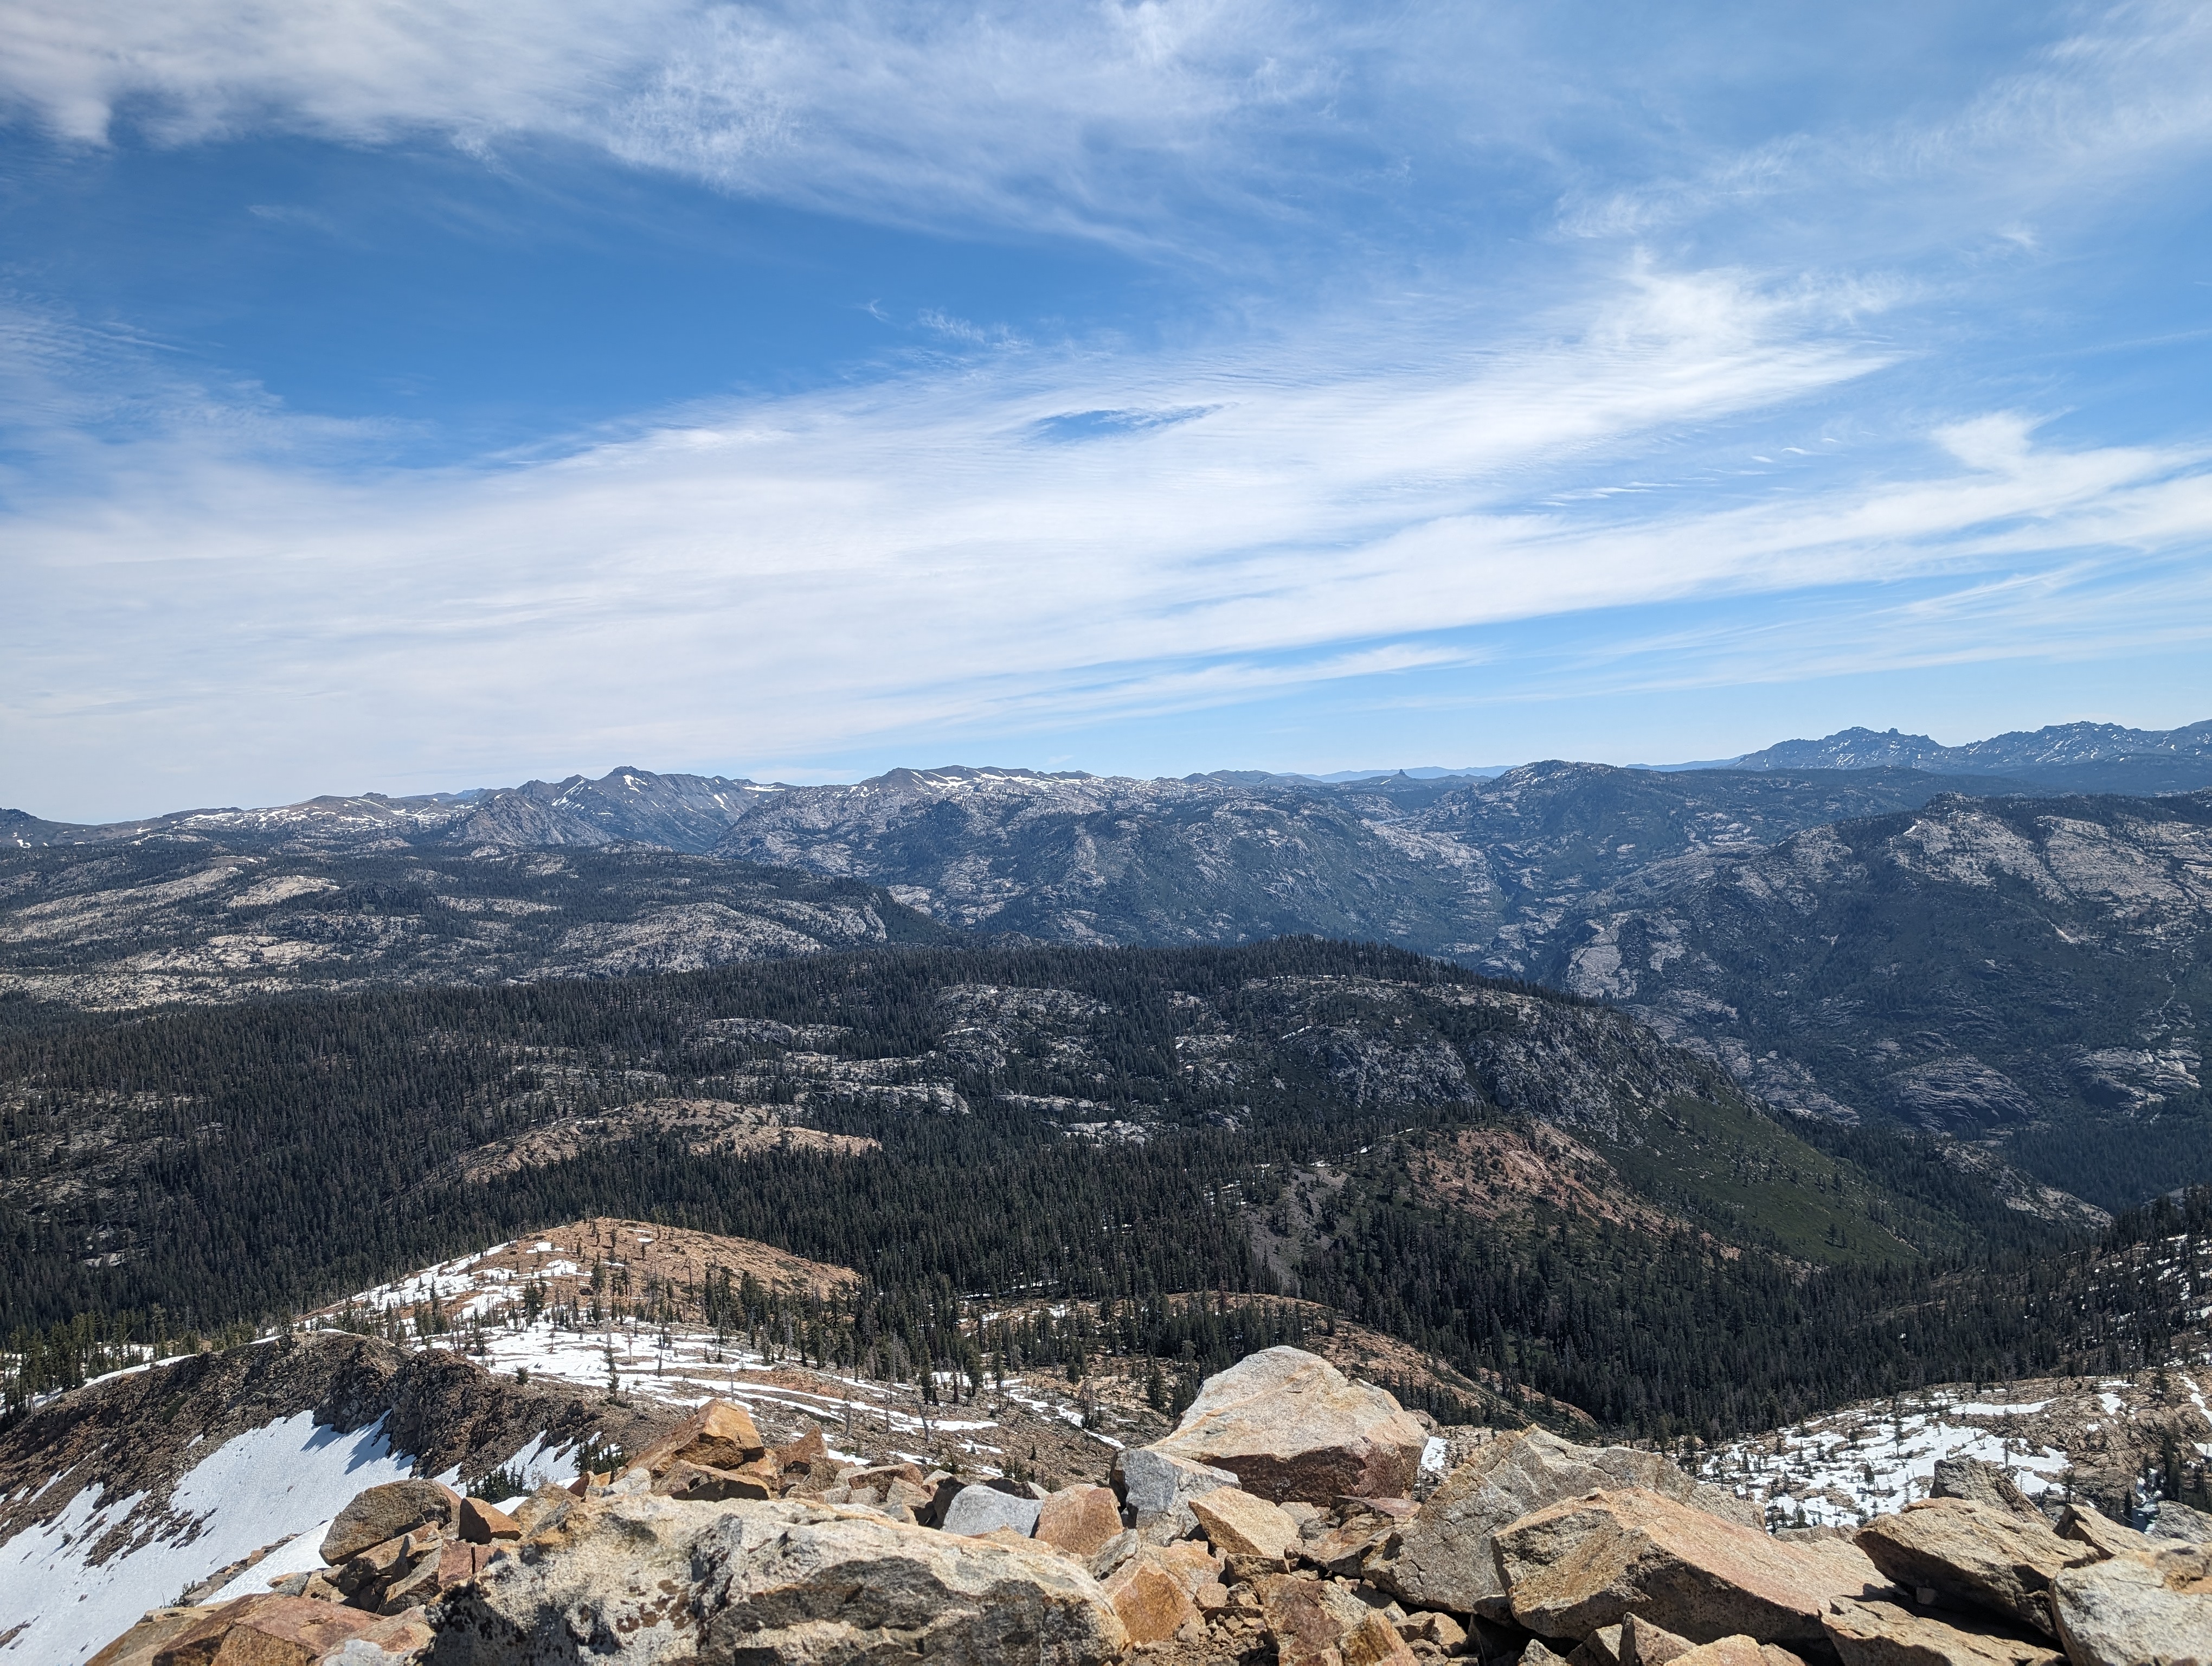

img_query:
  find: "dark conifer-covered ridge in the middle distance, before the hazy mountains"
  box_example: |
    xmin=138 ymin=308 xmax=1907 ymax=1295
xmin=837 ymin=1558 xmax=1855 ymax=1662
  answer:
xmin=0 ymin=940 xmax=2176 ymax=1432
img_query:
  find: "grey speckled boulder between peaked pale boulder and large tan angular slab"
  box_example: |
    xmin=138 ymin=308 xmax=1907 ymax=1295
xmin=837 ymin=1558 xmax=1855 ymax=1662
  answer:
xmin=1367 ymin=1429 xmax=1759 ymax=1619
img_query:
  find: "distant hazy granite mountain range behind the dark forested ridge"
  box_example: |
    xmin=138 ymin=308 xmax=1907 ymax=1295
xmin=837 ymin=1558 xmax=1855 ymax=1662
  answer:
xmin=0 ymin=723 xmax=2212 ymax=1208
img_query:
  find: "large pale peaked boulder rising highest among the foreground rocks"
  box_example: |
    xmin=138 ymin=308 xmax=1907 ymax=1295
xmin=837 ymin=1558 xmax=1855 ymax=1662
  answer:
xmin=1150 ymin=1348 xmax=1429 ymax=1502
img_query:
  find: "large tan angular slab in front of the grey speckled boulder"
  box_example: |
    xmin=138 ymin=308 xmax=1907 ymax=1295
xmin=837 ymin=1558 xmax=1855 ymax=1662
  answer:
xmin=1495 ymin=1487 xmax=1885 ymax=1644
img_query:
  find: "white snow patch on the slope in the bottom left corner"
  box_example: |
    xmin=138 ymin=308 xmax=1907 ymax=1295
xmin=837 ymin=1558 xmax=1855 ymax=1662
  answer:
xmin=0 ymin=1412 xmax=414 ymax=1666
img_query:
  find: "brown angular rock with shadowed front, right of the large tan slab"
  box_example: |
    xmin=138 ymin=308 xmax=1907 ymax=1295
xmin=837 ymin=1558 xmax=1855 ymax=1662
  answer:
xmin=1854 ymin=1498 xmax=2104 ymax=1633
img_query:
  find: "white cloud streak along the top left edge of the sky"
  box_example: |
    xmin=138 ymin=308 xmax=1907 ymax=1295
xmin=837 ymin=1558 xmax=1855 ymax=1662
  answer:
xmin=0 ymin=0 xmax=1380 ymax=246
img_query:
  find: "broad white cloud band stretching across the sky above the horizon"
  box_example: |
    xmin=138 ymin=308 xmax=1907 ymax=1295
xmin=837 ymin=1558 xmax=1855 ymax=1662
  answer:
xmin=0 ymin=252 xmax=2212 ymax=805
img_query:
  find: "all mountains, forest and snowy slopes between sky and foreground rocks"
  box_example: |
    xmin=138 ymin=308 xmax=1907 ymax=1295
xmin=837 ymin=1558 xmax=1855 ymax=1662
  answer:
xmin=0 ymin=726 xmax=2212 ymax=1657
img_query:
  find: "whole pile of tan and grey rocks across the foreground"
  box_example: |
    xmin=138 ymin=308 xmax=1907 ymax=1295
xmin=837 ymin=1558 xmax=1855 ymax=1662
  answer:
xmin=93 ymin=1348 xmax=2212 ymax=1666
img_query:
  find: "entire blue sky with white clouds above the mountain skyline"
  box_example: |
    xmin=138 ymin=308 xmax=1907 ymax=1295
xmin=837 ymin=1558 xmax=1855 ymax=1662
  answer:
xmin=0 ymin=0 xmax=2212 ymax=818
